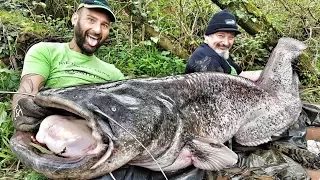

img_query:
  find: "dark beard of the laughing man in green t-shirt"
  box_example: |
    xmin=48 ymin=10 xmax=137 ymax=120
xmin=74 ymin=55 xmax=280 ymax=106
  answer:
xmin=74 ymin=21 xmax=102 ymax=55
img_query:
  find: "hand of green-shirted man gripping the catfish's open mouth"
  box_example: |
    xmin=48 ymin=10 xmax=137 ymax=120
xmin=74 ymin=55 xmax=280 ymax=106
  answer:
xmin=12 ymin=98 xmax=53 ymax=132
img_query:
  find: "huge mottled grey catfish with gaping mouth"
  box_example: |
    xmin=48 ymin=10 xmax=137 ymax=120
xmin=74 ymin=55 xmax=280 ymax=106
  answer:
xmin=10 ymin=38 xmax=306 ymax=179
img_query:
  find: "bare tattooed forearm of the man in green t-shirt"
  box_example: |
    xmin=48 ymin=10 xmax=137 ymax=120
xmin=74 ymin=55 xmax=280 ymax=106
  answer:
xmin=12 ymin=74 xmax=45 ymax=109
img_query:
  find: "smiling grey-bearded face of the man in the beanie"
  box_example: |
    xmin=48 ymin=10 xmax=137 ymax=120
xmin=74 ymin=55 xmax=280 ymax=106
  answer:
xmin=206 ymin=31 xmax=235 ymax=59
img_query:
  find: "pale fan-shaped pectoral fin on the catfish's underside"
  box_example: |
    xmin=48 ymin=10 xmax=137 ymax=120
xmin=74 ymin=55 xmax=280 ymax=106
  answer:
xmin=191 ymin=140 xmax=238 ymax=170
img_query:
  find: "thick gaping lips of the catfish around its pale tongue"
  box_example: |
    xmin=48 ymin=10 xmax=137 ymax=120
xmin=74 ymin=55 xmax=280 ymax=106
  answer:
xmin=10 ymin=93 xmax=114 ymax=177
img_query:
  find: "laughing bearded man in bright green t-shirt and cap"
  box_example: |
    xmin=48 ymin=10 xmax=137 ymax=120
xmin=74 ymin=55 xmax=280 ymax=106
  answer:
xmin=12 ymin=0 xmax=124 ymax=131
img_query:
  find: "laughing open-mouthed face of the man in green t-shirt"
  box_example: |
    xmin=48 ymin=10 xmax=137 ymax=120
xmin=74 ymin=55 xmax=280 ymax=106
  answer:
xmin=71 ymin=8 xmax=110 ymax=55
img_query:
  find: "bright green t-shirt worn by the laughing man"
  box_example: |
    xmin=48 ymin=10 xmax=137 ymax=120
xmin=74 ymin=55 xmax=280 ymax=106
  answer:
xmin=22 ymin=42 xmax=124 ymax=88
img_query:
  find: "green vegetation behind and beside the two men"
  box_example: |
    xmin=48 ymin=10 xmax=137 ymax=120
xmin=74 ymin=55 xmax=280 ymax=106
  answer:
xmin=0 ymin=0 xmax=320 ymax=179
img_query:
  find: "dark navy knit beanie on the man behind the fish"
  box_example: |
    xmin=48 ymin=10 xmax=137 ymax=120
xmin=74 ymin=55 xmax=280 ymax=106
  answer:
xmin=205 ymin=9 xmax=241 ymax=35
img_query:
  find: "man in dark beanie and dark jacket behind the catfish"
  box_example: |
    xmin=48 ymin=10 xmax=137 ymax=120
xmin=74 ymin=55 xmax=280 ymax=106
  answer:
xmin=185 ymin=10 xmax=261 ymax=81
